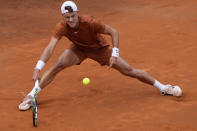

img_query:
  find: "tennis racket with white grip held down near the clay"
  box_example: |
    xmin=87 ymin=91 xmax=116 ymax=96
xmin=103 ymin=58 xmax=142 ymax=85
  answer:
xmin=32 ymin=80 xmax=39 ymax=127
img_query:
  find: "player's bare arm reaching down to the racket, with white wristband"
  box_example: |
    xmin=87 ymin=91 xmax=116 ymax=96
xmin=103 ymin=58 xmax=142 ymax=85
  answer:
xmin=32 ymin=37 xmax=59 ymax=81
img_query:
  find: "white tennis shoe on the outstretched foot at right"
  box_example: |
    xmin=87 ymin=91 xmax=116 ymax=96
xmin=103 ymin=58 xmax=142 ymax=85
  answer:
xmin=160 ymin=85 xmax=182 ymax=97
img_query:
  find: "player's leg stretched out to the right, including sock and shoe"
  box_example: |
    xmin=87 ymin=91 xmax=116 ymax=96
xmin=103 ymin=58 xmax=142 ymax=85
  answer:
xmin=112 ymin=57 xmax=182 ymax=96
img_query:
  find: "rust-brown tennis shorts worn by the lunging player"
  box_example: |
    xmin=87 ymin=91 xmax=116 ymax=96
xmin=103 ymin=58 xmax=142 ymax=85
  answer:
xmin=70 ymin=45 xmax=112 ymax=66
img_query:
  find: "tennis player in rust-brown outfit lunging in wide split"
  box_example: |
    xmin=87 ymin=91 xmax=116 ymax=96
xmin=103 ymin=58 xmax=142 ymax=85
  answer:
xmin=19 ymin=1 xmax=182 ymax=110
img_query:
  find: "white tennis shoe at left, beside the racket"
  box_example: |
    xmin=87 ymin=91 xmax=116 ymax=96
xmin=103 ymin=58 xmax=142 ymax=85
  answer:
xmin=18 ymin=95 xmax=33 ymax=111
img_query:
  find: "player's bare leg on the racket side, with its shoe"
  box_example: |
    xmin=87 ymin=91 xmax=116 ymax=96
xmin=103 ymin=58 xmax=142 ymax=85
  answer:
xmin=18 ymin=49 xmax=85 ymax=110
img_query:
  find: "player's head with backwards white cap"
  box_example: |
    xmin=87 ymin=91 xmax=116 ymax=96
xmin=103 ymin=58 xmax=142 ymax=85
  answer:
xmin=61 ymin=1 xmax=79 ymax=28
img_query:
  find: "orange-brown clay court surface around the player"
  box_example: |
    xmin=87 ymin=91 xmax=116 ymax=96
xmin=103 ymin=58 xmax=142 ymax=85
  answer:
xmin=0 ymin=0 xmax=197 ymax=131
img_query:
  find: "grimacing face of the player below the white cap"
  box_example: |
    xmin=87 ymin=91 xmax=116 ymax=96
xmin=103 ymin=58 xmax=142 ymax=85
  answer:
xmin=62 ymin=11 xmax=79 ymax=28
